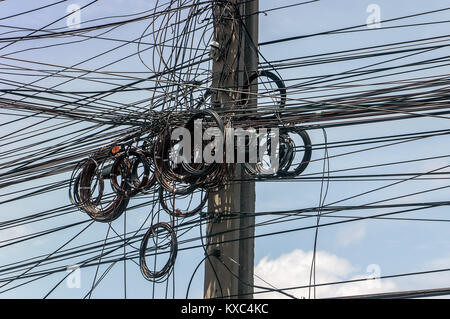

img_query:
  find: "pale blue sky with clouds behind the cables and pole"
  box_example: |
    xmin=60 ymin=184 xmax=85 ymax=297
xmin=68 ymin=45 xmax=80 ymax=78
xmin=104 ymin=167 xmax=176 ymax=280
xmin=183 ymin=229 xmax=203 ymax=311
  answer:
xmin=0 ymin=0 xmax=450 ymax=298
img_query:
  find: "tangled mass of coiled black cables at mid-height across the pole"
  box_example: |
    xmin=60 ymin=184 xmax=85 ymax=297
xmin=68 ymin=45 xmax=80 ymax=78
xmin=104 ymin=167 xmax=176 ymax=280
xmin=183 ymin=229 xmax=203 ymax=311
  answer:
xmin=69 ymin=110 xmax=312 ymax=222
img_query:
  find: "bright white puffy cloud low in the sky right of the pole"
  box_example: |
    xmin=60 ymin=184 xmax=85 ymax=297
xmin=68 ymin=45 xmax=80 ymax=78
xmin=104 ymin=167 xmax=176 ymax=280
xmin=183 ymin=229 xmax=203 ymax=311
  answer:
xmin=255 ymin=249 xmax=396 ymax=298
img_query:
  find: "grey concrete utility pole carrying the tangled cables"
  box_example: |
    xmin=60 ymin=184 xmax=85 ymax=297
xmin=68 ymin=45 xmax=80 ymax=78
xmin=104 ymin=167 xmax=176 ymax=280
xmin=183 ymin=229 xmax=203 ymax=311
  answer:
xmin=204 ymin=0 xmax=259 ymax=299
